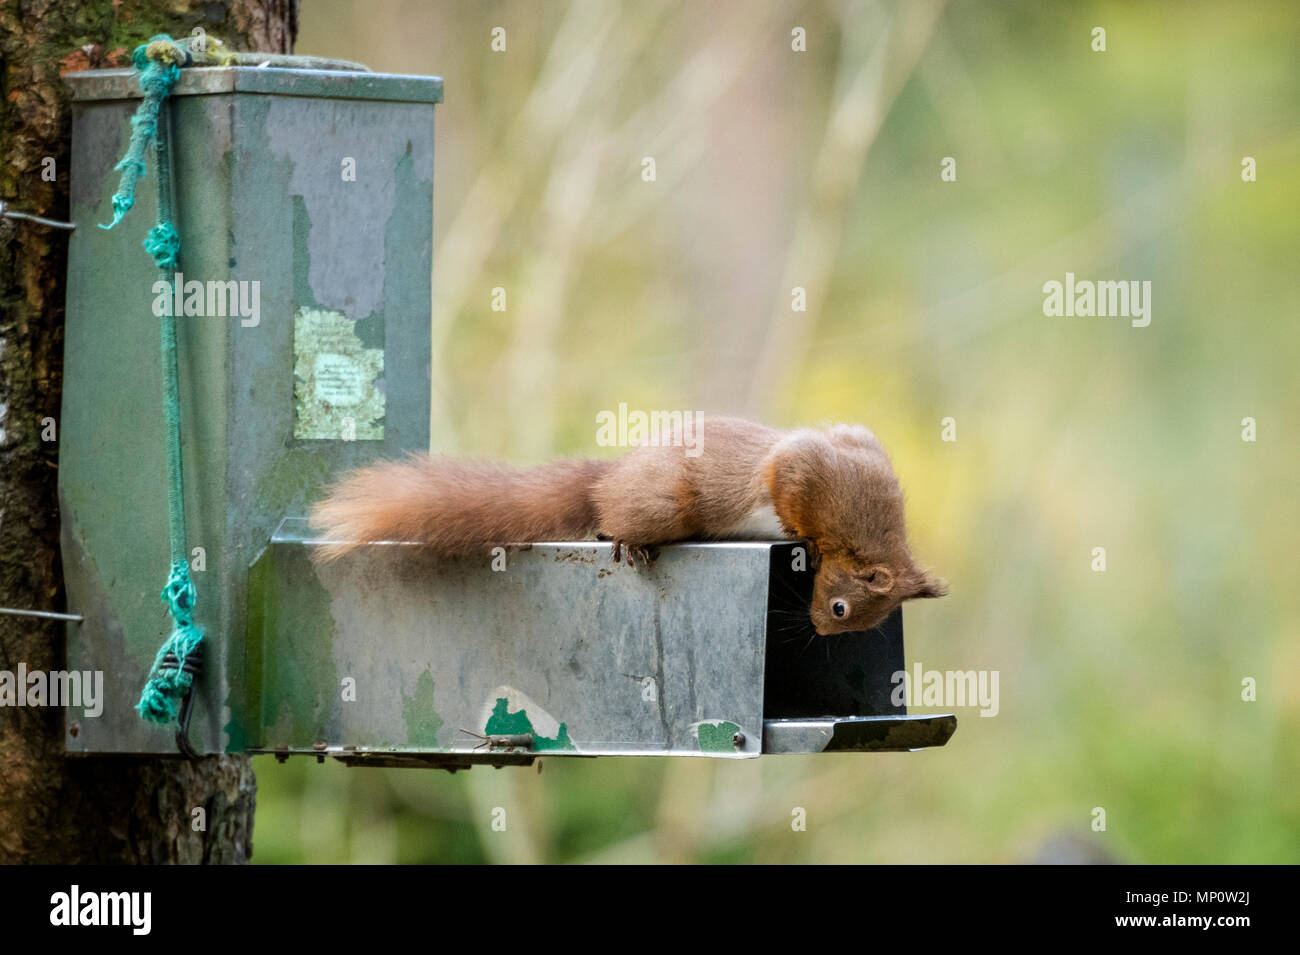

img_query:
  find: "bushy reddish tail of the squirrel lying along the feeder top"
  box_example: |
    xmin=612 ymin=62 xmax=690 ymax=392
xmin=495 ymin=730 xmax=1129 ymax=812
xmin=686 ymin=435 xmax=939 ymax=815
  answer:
xmin=311 ymin=453 xmax=611 ymax=560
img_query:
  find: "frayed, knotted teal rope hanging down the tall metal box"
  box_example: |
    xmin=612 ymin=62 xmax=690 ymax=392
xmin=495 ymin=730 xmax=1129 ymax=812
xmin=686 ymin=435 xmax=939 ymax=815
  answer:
xmin=100 ymin=36 xmax=203 ymax=722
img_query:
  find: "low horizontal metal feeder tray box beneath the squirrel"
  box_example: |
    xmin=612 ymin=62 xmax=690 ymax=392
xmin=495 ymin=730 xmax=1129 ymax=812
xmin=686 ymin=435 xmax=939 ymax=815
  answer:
xmin=247 ymin=530 xmax=957 ymax=769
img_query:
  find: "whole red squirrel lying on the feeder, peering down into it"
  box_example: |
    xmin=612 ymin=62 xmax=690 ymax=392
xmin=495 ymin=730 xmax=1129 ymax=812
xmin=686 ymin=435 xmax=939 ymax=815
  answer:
xmin=311 ymin=417 xmax=946 ymax=635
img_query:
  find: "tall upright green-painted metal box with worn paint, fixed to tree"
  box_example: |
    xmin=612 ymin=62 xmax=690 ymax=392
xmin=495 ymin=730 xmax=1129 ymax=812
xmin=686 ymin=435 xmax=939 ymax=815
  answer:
xmin=59 ymin=68 xmax=442 ymax=752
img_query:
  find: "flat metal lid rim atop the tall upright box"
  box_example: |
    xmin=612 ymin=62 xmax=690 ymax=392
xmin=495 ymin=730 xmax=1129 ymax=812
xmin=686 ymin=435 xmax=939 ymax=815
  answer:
xmin=64 ymin=66 xmax=442 ymax=103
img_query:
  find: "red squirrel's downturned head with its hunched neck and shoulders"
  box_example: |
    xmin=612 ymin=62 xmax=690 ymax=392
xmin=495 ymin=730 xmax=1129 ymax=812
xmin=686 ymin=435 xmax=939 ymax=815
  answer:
xmin=766 ymin=425 xmax=948 ymax=635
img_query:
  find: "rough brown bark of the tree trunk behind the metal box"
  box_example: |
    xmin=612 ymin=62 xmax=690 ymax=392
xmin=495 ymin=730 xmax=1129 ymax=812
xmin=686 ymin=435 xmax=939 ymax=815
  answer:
xmin=0 ymin=0 xmax=298 ymax=863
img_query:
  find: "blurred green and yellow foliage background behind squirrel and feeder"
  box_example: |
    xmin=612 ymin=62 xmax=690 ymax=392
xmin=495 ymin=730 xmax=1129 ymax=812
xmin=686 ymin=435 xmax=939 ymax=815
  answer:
xmin=255 ymin=0 xmax=1300 ymax=863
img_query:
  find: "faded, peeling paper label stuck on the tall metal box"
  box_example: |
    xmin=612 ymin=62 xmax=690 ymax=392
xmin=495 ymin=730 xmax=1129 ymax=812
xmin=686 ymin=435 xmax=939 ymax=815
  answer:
xmin=294 ymin=308 xmax=385 ymax=440
